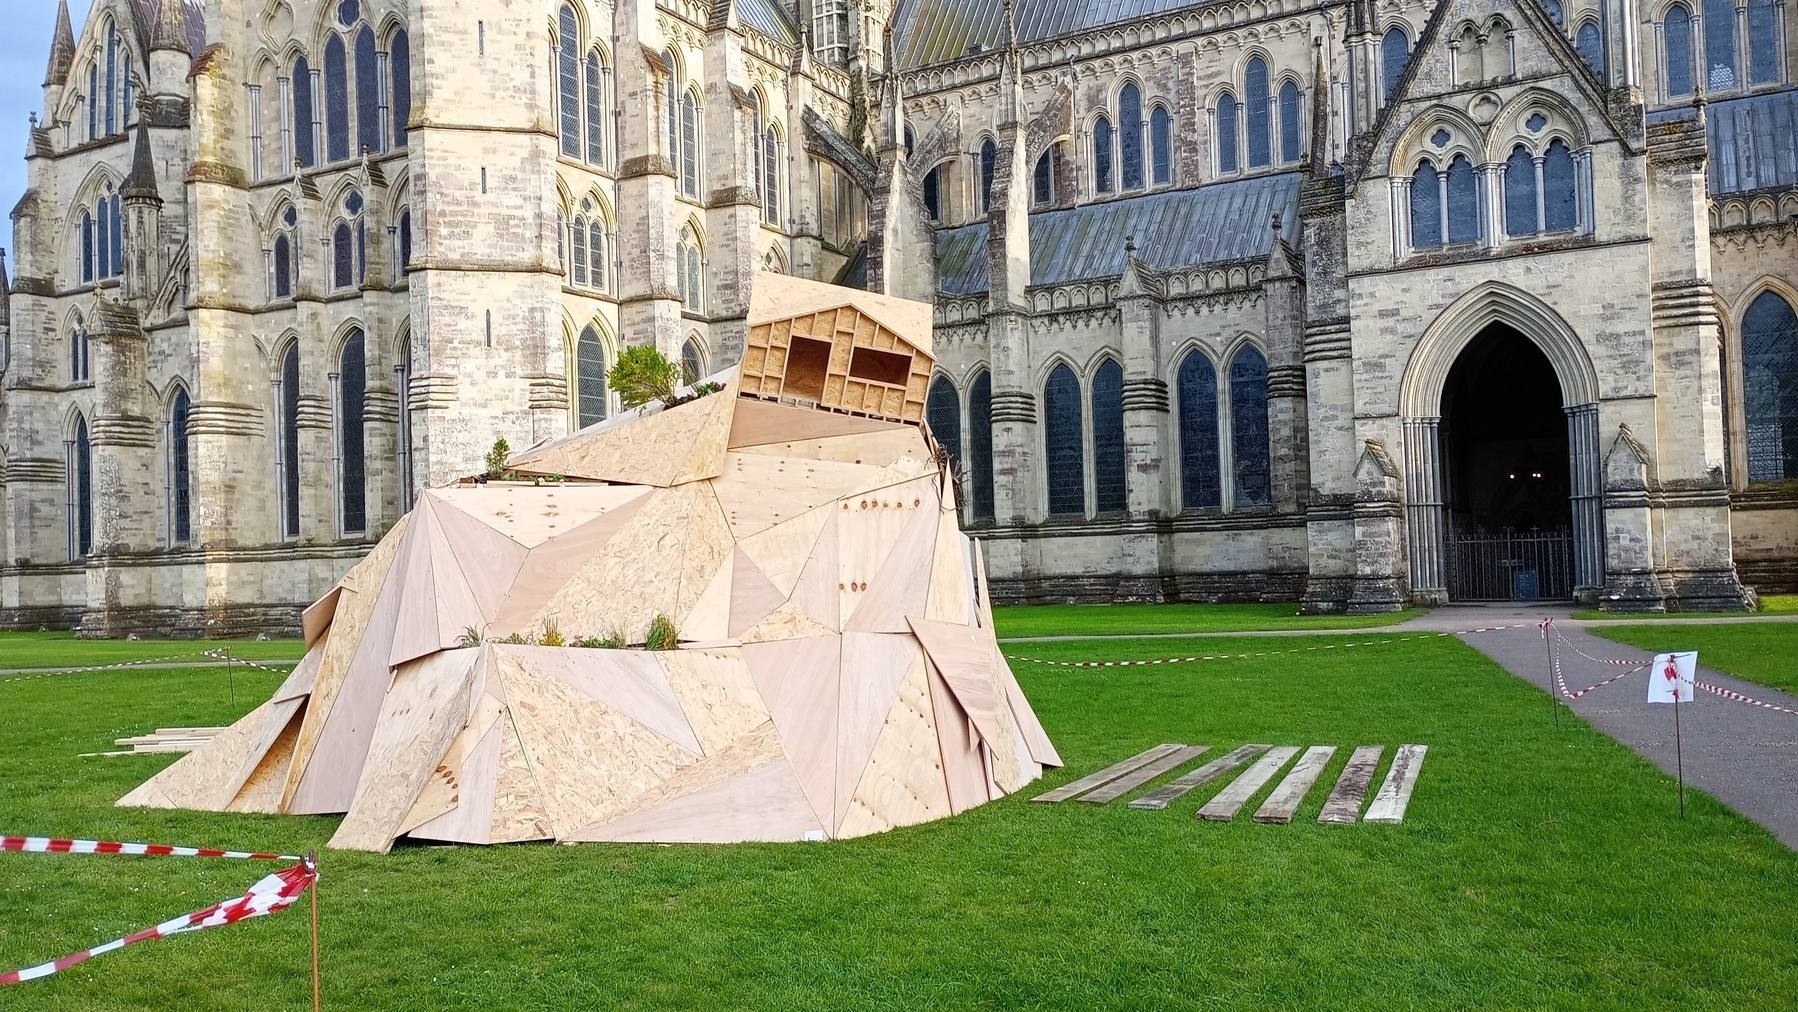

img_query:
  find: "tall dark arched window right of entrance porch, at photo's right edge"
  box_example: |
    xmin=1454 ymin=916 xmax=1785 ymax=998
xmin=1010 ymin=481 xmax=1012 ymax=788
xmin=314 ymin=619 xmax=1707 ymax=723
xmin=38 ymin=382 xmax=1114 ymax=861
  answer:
xmin=1742 ymin=291 xmax=1798 ymax=482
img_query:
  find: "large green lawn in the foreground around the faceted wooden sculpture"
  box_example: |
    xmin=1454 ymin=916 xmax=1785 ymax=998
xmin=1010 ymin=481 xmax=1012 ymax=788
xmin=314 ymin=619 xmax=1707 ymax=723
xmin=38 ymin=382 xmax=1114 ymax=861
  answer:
xmin=0 ymin=635 xmax=1798 ymax=1012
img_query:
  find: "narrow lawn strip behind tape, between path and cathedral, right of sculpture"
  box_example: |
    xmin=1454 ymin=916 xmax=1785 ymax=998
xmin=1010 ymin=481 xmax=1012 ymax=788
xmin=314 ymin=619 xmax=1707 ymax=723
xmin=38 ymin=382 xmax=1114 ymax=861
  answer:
xmin=992 ymin=604 xmax=1419 ymax=636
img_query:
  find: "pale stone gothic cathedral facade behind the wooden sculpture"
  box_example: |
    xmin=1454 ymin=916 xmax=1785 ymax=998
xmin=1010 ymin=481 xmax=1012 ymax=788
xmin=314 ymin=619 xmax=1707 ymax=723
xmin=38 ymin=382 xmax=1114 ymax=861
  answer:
xmin=0 ymin=0 xmax=1798 ymax=635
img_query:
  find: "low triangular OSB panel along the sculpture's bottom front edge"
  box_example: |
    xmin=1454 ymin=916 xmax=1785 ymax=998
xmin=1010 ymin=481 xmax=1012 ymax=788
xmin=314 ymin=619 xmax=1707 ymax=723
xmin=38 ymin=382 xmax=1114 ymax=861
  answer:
xmin=560 ymin=759 xmax=822 ymax=843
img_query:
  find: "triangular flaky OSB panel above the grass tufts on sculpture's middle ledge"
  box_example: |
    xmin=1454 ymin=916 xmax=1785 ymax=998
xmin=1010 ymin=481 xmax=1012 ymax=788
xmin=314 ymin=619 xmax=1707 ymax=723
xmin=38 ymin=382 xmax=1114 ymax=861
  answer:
xmin=507 ymin=484 xmax=716 ymax=644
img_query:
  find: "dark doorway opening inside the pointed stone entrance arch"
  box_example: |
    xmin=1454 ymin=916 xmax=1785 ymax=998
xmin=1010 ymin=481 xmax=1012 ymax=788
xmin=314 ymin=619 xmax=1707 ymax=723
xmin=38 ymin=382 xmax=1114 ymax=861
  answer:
xmin=1442 ymin=324 xmax=1573 ymax=600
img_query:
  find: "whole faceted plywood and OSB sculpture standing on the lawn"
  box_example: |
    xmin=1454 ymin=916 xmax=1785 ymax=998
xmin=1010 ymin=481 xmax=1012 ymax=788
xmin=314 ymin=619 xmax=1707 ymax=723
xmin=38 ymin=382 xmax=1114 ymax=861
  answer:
xmin=119 ymin=273 xmax=1061 ymax=852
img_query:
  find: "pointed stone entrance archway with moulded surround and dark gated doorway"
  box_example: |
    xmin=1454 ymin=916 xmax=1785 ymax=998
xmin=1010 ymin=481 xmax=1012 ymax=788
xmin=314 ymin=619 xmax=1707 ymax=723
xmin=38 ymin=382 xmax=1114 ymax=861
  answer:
xmin=1401 ymin=282 xmax=1604 ymax=604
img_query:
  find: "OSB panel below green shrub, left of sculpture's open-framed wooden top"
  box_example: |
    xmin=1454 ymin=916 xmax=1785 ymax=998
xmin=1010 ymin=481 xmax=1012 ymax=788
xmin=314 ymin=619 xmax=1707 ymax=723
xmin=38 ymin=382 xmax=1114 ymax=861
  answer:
xmin=511 ymin=379 xmax=737 ymax=487
